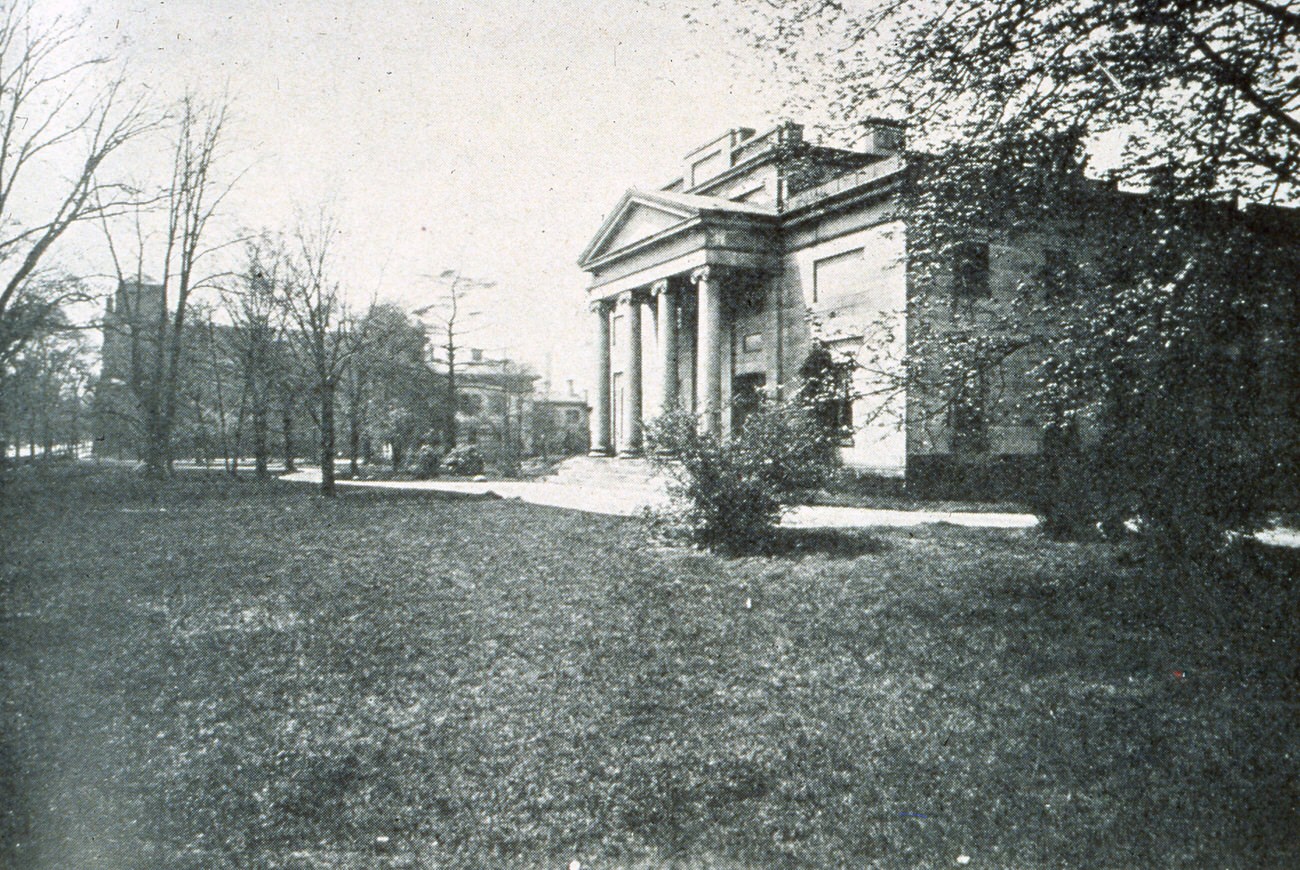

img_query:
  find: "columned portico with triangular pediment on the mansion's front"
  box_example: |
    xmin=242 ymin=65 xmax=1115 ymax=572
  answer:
xmin=580 ymin=191 xmax=776 ymax=456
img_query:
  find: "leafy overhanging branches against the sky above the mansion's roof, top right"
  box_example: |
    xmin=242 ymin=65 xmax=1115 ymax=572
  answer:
xmin=688 ymin=0 xmax=1300 ymax=202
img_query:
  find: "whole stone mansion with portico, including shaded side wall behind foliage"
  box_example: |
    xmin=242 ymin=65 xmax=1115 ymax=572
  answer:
xmin=579 ymin=121 xmax=1300 ymax=494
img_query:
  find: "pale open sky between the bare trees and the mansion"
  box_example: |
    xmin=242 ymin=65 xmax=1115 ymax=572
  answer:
xmin=46 ymin=0 xmax=780 ymax=386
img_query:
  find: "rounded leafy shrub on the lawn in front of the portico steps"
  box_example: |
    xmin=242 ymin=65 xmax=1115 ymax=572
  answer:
xmin=647 ymin=402 xmax=836 ymax=553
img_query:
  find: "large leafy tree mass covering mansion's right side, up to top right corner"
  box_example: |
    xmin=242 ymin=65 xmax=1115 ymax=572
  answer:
xmin=712 ymin=0 xmax=1300 ymax=562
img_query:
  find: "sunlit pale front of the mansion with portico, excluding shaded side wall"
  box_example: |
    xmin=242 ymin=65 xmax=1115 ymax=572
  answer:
xmin=579 ymin=122 xmax=920 ymax=476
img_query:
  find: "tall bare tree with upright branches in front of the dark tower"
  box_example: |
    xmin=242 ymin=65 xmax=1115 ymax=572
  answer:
xmin=105 ymin=95 xmax=231 ymax=476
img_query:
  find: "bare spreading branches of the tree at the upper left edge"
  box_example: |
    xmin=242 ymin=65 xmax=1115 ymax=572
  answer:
xmin=0 ymin=0 xmax=156 ymax=363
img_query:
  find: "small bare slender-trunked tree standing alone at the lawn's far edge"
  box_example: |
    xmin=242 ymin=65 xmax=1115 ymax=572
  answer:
xmin=281 ymin=215 xmax=365 ymax=497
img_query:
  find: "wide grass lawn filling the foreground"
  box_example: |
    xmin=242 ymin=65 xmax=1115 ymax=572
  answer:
xmin=0 ymin=469 xmax=1300 ymax=869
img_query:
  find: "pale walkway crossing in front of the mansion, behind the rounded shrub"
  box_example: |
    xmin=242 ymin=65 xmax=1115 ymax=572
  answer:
xmin=281 ymin=468 xmax=1039 ymax=529
